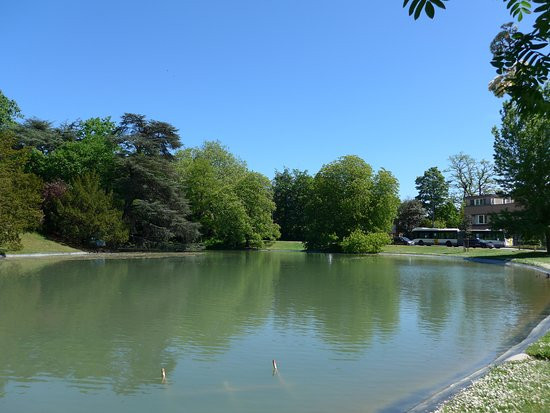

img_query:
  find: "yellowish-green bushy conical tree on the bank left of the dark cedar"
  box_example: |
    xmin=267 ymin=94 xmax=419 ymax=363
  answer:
xmin=53 ymin=173 xmax=128 ymax=246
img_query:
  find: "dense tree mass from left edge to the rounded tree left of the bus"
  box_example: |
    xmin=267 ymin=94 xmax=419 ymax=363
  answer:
xmin=0 ymin=92 xmax=399 ymax=252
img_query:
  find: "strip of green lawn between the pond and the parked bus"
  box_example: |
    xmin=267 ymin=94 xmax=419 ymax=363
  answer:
xmin=382 ymin=245 xmax=550 ymax=269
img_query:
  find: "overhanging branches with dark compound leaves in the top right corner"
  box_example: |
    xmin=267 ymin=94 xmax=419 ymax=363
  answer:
xmin=403 ymin=0 xmax=550 ymax=115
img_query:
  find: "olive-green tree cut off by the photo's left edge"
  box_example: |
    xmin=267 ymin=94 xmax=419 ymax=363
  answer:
xmin=0 ymin=131 xmax=42 ymax=249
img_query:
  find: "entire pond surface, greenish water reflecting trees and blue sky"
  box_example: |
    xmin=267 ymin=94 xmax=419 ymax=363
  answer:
xmin=0 ymin=252 xmax=550 ymax=413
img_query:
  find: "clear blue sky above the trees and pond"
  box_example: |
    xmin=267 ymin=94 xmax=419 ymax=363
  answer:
xmin=0 ymin=0 xmax=528 ymax=198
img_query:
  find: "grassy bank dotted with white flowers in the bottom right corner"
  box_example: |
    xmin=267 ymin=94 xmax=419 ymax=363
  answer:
xmin=436 ymin=333 xmax=550 ymax=413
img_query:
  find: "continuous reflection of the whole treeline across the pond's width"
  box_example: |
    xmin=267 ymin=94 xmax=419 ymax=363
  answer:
xmin=0 ymin=252 xmax=550 ymax=394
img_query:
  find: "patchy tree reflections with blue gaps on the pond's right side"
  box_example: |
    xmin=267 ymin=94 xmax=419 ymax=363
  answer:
xmin=396 ymin=258 xmax=550 ymax=352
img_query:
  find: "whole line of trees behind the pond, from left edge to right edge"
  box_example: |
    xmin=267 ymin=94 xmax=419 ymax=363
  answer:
xmin=0 ymin=83 xmax=550 ymax=252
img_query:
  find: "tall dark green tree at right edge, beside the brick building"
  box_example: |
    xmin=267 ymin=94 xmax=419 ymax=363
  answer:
xmin=491 ymin=97 xmax=550 ymax=254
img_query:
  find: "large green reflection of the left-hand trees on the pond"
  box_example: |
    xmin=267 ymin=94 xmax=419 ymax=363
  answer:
xmin=0 ymin=253 xmax=278 ymax=393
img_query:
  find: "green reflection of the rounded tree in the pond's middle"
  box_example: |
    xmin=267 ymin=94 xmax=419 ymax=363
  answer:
xmin=274 ymin=254 xmax=399 ymax=352
